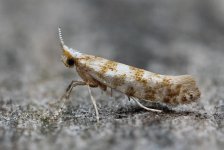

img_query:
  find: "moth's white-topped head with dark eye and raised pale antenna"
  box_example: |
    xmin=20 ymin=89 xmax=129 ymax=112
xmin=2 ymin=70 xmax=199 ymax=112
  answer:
xmin=58 ymin=28 xmax=75 ymax=68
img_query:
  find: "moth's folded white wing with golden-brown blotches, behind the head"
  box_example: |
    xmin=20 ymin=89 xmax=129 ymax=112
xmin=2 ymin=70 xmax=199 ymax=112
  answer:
xmin=77 ymin=54 xmax=200 ymax=104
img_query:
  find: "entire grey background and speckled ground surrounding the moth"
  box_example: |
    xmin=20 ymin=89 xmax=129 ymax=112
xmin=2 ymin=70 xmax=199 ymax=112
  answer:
xmin=0 ymin=0 xmax=224 ymax=150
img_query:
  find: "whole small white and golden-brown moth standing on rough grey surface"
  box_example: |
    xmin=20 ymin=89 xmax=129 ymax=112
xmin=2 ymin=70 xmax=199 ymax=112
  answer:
xmin=58 ymin=28 xmax=200 ymax=121
